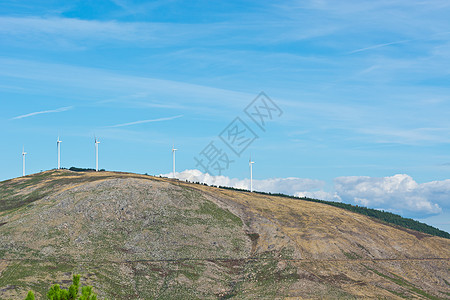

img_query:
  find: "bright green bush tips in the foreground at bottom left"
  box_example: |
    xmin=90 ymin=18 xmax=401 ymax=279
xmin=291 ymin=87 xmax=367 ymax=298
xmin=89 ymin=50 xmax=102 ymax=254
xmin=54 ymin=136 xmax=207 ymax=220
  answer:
xmin=25 ymin=275 xmax=97 ymax=300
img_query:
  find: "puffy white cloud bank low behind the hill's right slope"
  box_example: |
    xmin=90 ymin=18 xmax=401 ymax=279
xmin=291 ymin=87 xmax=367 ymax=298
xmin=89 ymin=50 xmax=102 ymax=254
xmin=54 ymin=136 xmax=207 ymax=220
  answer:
xmin=165 ymin=169 xmax=450 ymax=232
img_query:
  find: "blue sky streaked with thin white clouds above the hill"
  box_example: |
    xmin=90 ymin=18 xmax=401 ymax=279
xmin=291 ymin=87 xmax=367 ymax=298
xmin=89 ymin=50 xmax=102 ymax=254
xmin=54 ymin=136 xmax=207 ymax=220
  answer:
xmin=0 ymin=0 xmax=450 ymax=231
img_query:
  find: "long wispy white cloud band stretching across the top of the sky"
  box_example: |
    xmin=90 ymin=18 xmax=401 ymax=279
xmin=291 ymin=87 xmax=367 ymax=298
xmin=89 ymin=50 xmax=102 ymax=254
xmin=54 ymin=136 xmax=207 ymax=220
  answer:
xmin=0 ymin=14 xmax=337 ymax=50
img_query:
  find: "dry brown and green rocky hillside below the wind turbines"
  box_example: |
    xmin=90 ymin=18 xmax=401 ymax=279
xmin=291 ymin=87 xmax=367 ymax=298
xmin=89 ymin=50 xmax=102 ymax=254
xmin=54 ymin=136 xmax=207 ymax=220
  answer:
xmin=0 ymin=170 xmax=450 ymax=299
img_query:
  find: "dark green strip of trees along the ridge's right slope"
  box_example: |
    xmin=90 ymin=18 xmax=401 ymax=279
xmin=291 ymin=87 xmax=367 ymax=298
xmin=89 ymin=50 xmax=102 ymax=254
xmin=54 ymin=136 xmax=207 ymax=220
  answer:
xmin=218 ymin=186 xmax=450 ymax=239
